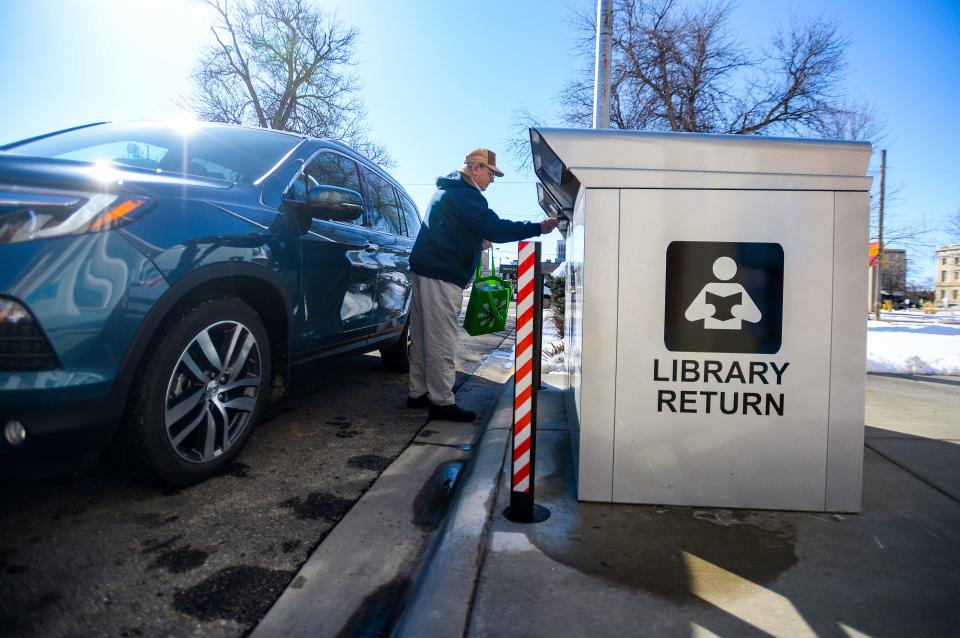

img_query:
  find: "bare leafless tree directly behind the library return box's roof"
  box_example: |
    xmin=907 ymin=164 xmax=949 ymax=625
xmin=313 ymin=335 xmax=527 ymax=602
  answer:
xmin=560 ymin=0 xmax=870 ymax=137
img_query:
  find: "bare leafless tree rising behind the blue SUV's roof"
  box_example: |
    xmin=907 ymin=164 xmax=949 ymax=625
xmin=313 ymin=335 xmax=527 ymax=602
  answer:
xmin=186 ymin=0 xmax=392 ymax=165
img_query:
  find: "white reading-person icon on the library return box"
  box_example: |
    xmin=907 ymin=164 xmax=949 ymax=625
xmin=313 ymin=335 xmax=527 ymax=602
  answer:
xmin=683 ymin=257 xmax=763 ymax=330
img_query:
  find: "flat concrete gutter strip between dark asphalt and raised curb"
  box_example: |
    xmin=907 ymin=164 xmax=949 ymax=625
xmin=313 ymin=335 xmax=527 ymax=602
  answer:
xmin=251 ymin=348 xmax=512 ymax=638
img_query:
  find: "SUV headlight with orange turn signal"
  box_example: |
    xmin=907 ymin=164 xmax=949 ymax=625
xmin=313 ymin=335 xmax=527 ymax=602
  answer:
xmin=0 ymin=188 xmax=150 ymax=244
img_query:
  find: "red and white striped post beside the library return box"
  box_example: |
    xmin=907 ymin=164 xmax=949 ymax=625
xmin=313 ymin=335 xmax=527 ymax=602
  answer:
xmin=506 ymin=241 xmax=549 ymax=523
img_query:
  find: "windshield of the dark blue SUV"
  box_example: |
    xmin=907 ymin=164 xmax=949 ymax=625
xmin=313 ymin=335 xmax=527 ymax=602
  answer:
xmin=4 ymin=122 xmax=302 ymax=182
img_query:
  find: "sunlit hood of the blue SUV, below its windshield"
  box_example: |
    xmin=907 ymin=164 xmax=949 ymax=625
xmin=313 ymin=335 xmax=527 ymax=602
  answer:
xmin=0 ymin=153 xmax=233 ymax=192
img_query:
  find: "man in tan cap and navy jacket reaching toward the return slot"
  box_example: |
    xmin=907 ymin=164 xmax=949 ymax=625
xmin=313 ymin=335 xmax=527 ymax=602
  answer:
xmin=407 ymin=148 xmax=557 ymax=422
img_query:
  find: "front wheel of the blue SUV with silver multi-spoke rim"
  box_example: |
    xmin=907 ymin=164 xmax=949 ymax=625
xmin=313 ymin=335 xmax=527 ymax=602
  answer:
xmin=115 ymin=296 xmax=270 ymax=486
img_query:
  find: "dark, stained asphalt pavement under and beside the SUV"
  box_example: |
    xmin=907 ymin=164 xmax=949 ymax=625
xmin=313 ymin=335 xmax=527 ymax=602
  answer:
xmin=0 ymin=356 xmax=427 ymax=638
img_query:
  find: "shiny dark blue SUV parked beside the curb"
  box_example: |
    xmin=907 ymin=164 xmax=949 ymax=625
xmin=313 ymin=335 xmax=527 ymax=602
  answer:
xmin=0 ymin=122 xmax=420 ymax=485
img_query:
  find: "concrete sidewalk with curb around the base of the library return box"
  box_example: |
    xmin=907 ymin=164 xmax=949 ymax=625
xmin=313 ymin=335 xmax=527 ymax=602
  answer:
xmin=394 ymin=375 xmax=960 ymax=637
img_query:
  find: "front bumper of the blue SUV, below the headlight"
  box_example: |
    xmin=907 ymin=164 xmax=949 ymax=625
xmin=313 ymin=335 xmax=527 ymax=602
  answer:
xmin=0 ymin=232 xmax=168 ymax=461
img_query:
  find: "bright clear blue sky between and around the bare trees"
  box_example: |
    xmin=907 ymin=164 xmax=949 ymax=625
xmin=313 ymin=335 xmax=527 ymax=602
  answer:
xmin=0 ymin=0 xmax=960 ymax=279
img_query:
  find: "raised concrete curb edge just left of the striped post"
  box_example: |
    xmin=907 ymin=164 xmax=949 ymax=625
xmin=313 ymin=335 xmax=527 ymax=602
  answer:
xmin=392 ymin=379 xmax=513 ymax=638
